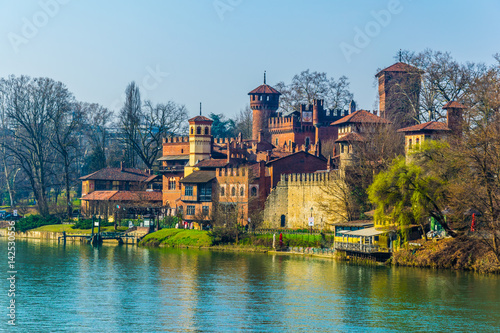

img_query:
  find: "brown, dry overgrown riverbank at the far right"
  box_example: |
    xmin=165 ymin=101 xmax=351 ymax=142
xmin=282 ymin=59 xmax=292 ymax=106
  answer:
xmin=392 ymin=236 xmax=500 ymax=273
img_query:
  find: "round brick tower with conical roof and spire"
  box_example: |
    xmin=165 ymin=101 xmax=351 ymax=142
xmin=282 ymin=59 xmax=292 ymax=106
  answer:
xmin=248 ymin=72 xmax=281 ymax=142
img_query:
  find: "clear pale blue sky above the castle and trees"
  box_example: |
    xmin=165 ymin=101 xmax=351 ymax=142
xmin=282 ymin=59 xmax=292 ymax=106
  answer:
xmin=0 ymin=0 xmax=500 ymax=116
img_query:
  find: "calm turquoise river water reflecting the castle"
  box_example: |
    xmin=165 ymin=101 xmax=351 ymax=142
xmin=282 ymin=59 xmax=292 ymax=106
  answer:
xmin=0 ymin=239 xmax=500 ymax=332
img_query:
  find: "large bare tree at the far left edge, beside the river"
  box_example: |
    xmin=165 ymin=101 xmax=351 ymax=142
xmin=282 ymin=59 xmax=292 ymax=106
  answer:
xmin=0 ymin=76 xmax=72 ymax=215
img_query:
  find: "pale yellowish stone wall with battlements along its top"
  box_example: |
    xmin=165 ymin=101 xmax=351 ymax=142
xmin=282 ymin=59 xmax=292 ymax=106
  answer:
xmin=262 ymin=171 xmax=341 ymax=230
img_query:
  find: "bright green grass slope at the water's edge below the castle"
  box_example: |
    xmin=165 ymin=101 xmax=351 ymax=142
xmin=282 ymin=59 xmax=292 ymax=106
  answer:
xmin=140 ymin=229 xmax=212 ymax=247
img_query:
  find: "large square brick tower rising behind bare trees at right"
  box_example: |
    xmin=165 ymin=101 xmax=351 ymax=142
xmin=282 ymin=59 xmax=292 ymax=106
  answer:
xmin=375 ymin=62 xmax=422 ymax=128
